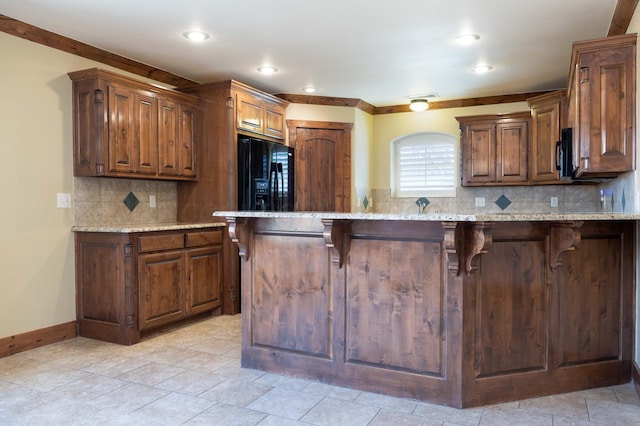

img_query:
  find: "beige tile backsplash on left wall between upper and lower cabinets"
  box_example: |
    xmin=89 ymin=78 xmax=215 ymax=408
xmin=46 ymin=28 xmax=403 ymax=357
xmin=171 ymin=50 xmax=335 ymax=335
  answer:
xmin=73 ymin=177 xmax=178 ymax=226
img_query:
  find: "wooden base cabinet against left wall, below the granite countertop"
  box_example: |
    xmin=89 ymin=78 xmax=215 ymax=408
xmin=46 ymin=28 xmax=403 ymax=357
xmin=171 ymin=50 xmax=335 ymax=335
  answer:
xmin=75 ymin=227 xmax=224 ymax=345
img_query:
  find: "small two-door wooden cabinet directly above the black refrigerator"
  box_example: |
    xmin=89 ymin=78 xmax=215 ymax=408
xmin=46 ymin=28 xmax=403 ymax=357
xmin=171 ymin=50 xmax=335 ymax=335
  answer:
xmin=236 ymin=90 xmax=285 ymax=139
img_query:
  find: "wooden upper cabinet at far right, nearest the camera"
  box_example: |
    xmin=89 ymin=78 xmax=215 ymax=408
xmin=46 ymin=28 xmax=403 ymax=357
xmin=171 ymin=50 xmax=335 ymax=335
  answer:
xmin=568 ymin=34 xmax=637 ymax=177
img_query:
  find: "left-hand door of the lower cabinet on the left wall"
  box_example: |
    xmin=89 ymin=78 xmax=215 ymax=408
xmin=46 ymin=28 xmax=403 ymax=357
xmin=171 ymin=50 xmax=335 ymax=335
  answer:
xmin=138 ymin=250 xmax=185 ymax=330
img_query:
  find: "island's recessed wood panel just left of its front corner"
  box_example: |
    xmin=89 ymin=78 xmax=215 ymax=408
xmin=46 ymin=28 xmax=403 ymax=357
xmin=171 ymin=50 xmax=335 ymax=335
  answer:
xmin=346 ymin=238 xmax=446 ymax=376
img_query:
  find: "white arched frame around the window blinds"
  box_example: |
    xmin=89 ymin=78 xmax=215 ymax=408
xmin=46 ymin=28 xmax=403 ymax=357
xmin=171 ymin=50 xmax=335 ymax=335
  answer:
xmin=390 ymin=132 xmax=459 ymax=198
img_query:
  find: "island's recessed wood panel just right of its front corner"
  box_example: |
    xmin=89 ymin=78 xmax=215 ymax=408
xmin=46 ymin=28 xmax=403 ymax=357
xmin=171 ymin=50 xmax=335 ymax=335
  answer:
xmin=475 ymin=236 xmax=547 ymax=377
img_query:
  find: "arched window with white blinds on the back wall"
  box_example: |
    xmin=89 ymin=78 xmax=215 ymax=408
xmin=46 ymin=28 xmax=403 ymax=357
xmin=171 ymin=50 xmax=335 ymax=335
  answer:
xmin=391 ymin=132 xmax=457 ymax=197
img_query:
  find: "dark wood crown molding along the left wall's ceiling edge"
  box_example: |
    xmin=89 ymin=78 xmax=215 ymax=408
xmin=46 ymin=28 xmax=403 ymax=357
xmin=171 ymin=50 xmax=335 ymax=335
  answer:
xmin=0 ymin=15 xmax=199 ymax=88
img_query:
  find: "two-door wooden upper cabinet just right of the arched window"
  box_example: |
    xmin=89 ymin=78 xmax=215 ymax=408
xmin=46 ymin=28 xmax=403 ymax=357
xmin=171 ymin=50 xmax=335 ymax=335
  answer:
xmin=456 ymin=112 xmax=531 ymax=186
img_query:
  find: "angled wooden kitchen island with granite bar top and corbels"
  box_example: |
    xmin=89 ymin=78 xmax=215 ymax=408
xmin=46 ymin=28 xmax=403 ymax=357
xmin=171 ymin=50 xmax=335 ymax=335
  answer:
xmin=214 ymin=212 xmax=640 ymax=407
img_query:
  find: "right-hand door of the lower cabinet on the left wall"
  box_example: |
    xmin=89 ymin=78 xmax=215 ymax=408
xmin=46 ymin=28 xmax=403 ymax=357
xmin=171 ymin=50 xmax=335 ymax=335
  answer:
xmin=186 ymin=245 xmax=222 ymax=315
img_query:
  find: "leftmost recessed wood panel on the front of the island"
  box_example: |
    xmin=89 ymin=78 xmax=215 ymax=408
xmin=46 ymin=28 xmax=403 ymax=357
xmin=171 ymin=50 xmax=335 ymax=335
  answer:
xmin=250 ymin=234 xmax=332 ymax=358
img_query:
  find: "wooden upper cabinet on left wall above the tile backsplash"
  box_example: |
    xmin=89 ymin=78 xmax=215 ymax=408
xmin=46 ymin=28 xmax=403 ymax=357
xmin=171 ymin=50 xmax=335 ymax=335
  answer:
xmin=69 ymin=68 xmax=198 ymax=180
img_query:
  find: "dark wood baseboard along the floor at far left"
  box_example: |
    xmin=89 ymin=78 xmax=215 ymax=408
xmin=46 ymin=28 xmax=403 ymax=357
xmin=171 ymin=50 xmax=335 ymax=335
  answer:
xmin=0 ymin=321 xmax=77 ymax=358
